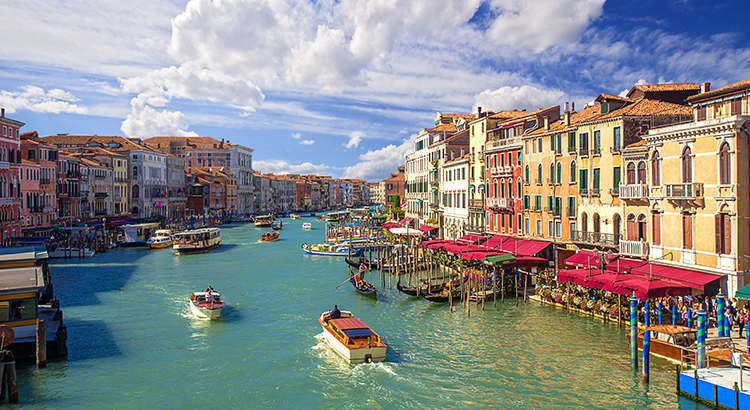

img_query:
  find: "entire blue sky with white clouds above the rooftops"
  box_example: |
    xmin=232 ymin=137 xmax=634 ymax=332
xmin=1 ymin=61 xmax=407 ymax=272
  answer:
xmin=0 ymin=0 xmax=750 ymax=182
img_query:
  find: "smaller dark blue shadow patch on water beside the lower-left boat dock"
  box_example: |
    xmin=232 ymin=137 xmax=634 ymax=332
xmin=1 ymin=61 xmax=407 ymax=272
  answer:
xmin=65 ymin=319 xmax=122 ymax=361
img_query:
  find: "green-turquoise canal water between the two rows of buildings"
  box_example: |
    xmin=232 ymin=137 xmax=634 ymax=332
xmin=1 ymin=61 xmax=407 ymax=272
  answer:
xmin=11 ymin=218 xmax=702 ymax=409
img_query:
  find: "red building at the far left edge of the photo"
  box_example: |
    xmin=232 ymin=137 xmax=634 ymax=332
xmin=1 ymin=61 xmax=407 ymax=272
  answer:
xmin=0 ymin=108 xmax=26 ymax=244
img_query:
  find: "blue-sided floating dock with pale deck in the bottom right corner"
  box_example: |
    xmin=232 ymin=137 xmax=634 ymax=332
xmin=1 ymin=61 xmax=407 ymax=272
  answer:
xmin=677 ymin=367 xmax=750 ymax=410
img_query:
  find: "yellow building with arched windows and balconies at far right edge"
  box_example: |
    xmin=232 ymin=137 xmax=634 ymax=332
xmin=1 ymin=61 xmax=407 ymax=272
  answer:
xmin=646 ymin=79 xmax=750 ymax=295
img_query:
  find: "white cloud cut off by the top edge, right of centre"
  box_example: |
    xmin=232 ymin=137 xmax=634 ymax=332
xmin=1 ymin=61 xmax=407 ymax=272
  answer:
xmin=487 ymin=0 xmax=605 ymax=53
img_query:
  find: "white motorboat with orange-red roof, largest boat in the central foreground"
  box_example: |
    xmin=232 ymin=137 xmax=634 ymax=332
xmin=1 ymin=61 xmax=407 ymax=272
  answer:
xmin=318 ymin=310 xmax=386 ymax=363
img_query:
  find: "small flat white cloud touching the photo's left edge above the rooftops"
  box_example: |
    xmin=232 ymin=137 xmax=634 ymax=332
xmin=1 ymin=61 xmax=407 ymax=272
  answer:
xmin=0 ymin=85 xmax=86 ymax=114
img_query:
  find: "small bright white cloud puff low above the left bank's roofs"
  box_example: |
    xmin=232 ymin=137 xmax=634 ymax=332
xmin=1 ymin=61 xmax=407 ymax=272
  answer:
xmin=120 ymin=98 xmax=198 ymax=137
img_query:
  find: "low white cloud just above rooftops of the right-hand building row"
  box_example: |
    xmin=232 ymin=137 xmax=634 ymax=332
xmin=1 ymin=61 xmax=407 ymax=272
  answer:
xmin=472 ymin=85 xmax=565 ymax=111
